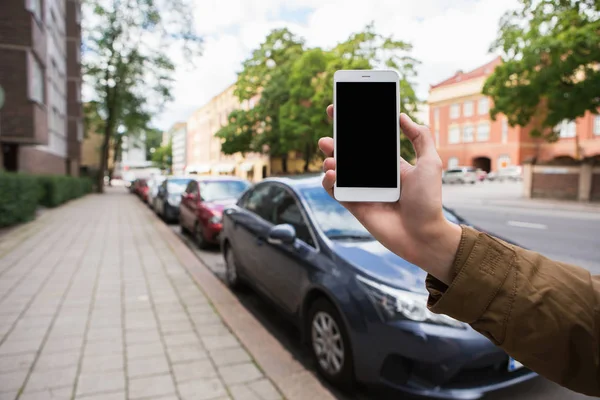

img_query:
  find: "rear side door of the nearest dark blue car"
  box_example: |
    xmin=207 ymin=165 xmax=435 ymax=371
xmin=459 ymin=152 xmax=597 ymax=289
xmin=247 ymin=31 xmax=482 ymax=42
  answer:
xmin=227 ymin=183 xmax=276 ymax=292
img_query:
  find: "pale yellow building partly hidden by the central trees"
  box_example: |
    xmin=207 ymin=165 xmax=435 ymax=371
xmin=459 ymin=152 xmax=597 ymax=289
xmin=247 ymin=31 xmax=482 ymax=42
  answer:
xmin=185 ymin=85 xmax=269 ymax=181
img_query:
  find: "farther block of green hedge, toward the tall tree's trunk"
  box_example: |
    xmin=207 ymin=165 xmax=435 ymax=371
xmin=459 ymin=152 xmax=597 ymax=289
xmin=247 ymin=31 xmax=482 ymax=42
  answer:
xmin=37 ymin=175 xmax=92 ymax=207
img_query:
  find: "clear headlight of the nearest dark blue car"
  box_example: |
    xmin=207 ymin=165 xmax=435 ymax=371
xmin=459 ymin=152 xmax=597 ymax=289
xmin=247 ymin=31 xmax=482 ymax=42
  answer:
xmin=356 ymin=276 xmax=467 ymax=329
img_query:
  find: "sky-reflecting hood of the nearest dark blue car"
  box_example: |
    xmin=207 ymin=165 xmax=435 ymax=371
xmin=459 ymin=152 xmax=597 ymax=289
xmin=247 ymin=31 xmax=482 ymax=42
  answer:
xmin=332 ymin=240 xmax=427 ymax=293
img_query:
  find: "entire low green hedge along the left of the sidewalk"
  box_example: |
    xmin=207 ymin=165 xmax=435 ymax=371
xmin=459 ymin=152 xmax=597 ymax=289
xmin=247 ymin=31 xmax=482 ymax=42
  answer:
xmin=0 ymin=172 xmax=92 ymax=227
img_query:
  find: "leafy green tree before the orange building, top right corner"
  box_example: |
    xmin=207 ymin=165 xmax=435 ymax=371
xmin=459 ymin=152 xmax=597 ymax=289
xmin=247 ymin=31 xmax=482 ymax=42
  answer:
xmin=483 ymin=0 xmax=600 ymax=158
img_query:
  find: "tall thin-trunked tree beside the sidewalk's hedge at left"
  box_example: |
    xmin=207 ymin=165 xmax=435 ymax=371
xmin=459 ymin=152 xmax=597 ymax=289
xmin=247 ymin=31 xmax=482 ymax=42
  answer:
xmin=83 ymin=0 xmax=202 ymax=191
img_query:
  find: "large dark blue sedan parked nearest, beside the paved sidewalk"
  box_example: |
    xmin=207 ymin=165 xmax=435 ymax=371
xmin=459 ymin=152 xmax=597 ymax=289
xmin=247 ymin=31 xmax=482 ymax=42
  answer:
xmin=222 ymin=178 xmax=536 ymax=399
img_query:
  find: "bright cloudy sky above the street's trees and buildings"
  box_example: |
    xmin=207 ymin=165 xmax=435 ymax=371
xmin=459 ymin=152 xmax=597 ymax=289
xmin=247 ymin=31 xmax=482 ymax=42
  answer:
xmin=153 ymin=0 xmax=517 ymax=130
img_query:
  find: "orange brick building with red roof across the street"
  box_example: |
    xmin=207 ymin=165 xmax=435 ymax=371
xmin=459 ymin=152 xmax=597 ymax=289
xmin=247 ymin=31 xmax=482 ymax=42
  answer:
xmin=427 ymin=57 xmax=600 ymax=172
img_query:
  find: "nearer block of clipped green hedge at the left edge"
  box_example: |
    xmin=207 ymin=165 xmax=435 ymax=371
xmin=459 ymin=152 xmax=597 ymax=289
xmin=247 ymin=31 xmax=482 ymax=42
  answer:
xmin=0 ymin=172 xmax=40 ymax=227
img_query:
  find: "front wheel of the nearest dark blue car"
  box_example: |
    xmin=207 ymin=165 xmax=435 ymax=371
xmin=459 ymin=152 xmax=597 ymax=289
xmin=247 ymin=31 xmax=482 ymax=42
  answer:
xmin=308 ymin=298 xmax=354 ymax=389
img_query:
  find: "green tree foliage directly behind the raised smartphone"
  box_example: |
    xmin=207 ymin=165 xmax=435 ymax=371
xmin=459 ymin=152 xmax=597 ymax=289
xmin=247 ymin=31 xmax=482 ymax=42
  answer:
xmin=217 ymin=25 xmax=418 ymax=170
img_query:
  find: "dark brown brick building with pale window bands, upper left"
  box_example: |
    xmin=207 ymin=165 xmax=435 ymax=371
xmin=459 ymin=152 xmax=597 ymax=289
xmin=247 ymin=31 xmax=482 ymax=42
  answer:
xmin=0 ymin=0 xmax=83 ymax=175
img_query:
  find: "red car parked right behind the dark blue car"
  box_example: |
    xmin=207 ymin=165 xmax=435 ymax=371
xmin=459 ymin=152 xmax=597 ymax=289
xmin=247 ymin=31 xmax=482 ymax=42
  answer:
xmin=179 ymin=176 xmax=250 ymax=248
